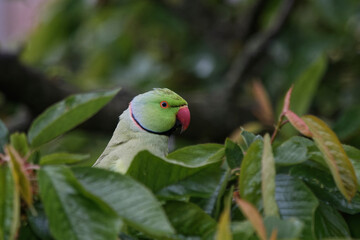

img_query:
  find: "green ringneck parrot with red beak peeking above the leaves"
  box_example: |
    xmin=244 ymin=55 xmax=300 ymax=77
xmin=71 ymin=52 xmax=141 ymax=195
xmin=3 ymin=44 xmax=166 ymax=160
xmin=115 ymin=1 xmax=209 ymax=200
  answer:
xmin=94 ymin=88 xmax=190 ymax=173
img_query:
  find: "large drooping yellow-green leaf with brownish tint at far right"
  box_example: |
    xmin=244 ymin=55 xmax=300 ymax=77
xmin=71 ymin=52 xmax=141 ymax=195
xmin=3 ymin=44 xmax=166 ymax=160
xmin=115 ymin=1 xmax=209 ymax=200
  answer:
xmin=302 ymin=115 xmax=358 ymax=201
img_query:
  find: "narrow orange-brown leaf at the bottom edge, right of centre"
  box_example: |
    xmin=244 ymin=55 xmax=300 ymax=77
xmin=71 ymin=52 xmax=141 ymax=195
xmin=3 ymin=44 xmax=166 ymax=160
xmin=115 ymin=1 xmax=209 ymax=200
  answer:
xmin=235 ymin=196 xmax=267 ymax=240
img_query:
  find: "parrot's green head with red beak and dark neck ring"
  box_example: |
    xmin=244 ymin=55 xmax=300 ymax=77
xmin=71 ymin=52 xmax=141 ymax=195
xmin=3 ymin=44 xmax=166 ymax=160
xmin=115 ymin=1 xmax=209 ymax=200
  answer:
xmin=129 ymin=88 xmax=190 ymax=135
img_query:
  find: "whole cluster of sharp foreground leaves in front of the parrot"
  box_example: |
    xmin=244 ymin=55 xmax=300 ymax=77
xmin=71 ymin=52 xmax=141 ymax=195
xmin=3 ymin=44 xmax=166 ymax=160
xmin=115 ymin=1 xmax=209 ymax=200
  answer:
xmin=0 ymin=89 xmax=360 ymax=240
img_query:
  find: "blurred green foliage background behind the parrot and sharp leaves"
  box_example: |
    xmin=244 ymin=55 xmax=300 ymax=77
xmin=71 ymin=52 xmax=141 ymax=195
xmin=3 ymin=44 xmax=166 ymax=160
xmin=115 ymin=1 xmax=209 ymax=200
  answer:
xmin=0 ymin=0 xmax=360 ymax=163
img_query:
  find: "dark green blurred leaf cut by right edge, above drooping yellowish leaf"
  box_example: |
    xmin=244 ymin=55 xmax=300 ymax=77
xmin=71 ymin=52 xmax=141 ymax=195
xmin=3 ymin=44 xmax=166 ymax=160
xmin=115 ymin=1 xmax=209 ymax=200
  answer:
xmin=333 ymin=105 xmax=360 ymax=139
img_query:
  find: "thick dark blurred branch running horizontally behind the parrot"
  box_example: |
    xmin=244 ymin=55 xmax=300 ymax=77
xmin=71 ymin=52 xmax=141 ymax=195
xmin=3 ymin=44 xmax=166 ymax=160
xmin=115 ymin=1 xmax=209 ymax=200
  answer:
xmin=0 ymin=53 xmax=253 ymax=142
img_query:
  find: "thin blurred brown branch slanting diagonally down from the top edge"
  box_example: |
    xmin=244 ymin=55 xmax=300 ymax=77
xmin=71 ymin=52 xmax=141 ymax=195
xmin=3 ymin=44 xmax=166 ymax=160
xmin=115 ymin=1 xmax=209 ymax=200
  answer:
xmin=224 ymin=0 xmax=295 ymax=102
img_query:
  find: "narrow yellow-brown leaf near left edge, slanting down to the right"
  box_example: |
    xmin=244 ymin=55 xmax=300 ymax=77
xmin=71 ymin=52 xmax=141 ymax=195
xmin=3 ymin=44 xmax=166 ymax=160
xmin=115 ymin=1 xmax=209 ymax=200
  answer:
xmin=5 ymin=146 xmax=33 ymax=206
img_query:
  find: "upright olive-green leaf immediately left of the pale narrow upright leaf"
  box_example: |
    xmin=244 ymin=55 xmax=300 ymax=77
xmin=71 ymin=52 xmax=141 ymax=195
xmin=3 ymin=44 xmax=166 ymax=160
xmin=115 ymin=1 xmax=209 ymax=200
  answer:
xmin=239 ymin=140 xmax=263 ymax=209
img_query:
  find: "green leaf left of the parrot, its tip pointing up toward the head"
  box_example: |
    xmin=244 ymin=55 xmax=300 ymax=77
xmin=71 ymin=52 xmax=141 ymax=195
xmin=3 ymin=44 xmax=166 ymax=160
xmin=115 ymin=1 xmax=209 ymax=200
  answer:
xmin=28 ymin=89 xmax=119 ymax=148
